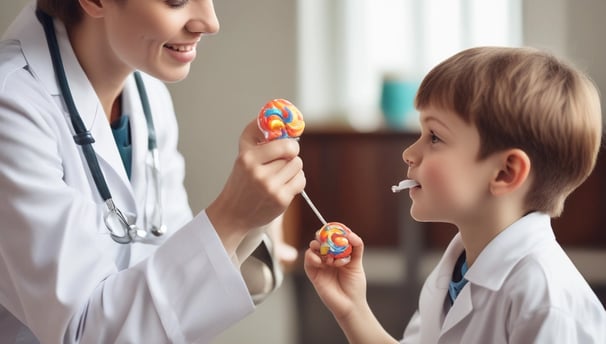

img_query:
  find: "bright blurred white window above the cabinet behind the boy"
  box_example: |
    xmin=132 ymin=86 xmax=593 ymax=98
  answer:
xmin=298 ymin=0 xmax=522 ymax=130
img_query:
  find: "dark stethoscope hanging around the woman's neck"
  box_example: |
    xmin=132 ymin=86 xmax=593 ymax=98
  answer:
xmin=36 ymin=10 xmax=166 ymax=244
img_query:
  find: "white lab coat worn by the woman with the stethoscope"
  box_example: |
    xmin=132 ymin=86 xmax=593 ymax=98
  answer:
xmin=0 ymin=4 xmax=278 ymax=343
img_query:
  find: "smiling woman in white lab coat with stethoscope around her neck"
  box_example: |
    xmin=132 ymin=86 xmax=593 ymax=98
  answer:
xmin=0 ymin=0 xmax=305 ymax=343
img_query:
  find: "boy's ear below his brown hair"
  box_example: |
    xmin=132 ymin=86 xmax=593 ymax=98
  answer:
xmin=490 ymin=148 xmax=530 ymax=196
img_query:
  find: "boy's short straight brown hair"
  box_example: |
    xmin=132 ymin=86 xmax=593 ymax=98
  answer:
xmin=415 ymin=47 xmax=602 ymax=217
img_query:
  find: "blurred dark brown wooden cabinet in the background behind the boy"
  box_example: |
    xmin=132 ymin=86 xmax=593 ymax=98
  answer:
xmin=287 ymin=130 xmax=606 ymax=249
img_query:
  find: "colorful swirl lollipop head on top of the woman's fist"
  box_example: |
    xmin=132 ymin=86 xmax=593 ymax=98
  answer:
xmin=257 ymin=99 xmax=305 ymax=141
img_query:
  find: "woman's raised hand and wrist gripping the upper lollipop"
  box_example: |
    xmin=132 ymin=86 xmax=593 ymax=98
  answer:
xmin=206 ymin=119 xmax=305 ymax=254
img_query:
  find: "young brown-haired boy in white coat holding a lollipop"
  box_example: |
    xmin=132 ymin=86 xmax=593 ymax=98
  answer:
xmin=305 ymin=47 xmax=606 ymax=344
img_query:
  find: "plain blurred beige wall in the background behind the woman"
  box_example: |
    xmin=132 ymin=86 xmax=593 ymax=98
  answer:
xmin=0 ymin=0 xmax=606 ymax=344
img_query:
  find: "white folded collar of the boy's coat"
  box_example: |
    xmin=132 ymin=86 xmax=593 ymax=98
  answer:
xmin=465 ymin=212 xmax=555 ymax=291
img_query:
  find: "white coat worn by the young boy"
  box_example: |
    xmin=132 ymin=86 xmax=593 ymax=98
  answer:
xmin=401 ymin=213 xmax=606 ymax=344
